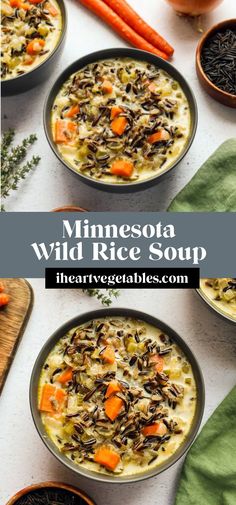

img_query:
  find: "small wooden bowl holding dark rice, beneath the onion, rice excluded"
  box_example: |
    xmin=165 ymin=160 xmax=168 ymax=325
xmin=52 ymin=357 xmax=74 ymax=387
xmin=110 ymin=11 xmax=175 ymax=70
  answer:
xmin=196 ymin=19 xmax=236 ymax=108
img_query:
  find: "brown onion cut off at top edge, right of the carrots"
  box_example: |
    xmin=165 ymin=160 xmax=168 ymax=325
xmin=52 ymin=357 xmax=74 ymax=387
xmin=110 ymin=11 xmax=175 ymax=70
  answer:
xmin=166 ymin=0 xmax=223 ymax=16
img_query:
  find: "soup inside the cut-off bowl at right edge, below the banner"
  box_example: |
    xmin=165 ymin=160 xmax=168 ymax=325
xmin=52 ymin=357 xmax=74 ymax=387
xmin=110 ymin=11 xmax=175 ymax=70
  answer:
xmin=200 ymin=277 xmax=236 ymax=320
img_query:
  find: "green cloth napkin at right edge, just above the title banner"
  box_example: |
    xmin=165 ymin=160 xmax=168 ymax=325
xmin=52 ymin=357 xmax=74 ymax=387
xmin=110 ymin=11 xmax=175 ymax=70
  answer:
xmin=167 ymin=138 xmax=236 ymax=212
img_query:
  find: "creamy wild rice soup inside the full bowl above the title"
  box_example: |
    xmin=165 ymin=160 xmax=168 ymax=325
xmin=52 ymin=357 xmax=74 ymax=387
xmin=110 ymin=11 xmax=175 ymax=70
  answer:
xmin=51 ymin=58 xmax=190 ymax=184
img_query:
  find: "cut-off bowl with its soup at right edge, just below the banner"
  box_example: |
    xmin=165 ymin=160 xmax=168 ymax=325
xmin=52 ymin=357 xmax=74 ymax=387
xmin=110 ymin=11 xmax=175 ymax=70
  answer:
xmin=197 ymin=277 xmax=236 ymax=324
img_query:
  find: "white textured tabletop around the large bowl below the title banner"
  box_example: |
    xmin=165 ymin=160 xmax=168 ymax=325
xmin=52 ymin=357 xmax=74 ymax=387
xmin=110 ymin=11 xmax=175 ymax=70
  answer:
xmin=0 ymin=279 xmax=236 ymax=505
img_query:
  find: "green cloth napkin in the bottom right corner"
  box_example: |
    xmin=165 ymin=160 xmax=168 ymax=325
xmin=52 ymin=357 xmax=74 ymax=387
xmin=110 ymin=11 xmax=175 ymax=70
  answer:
xmin=175 ymin=387 xmax=236 ymax=505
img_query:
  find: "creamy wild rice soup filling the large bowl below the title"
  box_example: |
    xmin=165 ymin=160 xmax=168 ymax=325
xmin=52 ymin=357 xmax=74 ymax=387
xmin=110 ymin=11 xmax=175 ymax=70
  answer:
xmin=38 ymin=317 xmax=196 ymax=475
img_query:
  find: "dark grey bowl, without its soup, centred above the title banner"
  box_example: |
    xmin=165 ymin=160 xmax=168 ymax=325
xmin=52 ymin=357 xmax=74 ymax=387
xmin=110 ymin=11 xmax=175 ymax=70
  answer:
xmin=44 ymin=48 xmax=198 ymax=193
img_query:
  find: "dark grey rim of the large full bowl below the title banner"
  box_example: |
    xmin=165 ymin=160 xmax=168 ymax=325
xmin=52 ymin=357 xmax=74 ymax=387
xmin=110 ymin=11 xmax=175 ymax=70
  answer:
xmin=29 ymin=308 xmax=205 ymax=484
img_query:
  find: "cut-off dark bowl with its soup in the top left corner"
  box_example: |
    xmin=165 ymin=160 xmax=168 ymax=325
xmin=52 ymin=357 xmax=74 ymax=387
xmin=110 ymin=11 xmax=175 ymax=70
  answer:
xmin=1 ymin=0 xmax=67 ymax=96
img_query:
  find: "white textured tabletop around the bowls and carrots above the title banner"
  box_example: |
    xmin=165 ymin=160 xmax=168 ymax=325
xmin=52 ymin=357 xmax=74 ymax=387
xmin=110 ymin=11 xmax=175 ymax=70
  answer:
xmin=2 ymin=0 xmax=236 ymax=211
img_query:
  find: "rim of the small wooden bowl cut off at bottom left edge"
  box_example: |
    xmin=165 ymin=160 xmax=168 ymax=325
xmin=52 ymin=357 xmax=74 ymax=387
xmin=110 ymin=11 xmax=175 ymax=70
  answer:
xmin=6 ymin=481 xmax=96 ymax=505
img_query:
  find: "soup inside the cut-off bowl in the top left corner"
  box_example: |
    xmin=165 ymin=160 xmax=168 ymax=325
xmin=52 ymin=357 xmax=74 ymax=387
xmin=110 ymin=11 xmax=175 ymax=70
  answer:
xmin=1 ymin=0 xmax=62 ymax=80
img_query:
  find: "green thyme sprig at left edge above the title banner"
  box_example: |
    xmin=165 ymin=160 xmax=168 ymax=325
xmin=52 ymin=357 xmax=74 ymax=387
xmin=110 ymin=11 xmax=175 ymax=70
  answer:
xmin=1 ymin=129 xmax=40 ymax=211
